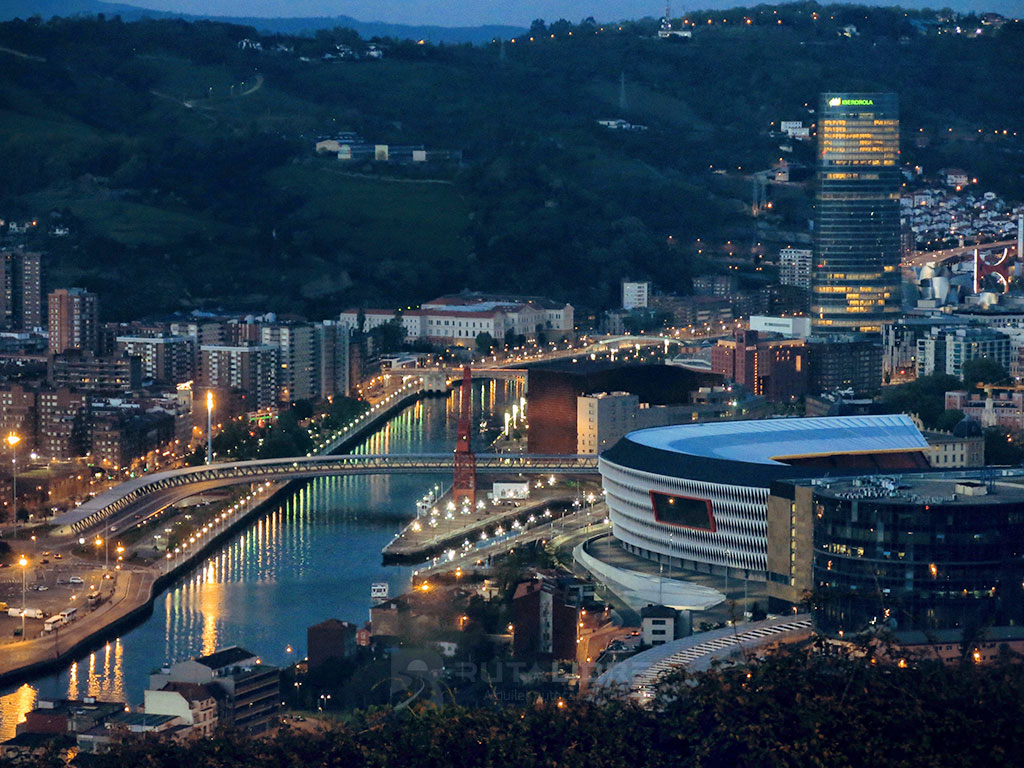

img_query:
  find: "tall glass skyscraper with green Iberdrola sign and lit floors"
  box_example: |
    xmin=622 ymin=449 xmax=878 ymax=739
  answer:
xmin=811 ymin=93 xmax=900 ymax=333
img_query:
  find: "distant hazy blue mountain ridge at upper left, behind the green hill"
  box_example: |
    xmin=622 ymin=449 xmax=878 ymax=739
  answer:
xmin=0 ymin=0 xmax=525 ymax=43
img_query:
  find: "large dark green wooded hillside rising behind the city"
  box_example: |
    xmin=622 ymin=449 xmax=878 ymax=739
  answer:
xmin=0 ymin=4 xmax=1024 ymax=317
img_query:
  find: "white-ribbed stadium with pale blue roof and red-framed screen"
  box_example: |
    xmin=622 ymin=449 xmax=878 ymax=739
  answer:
xmin=599 ymin=416 xmax=928 ymax=580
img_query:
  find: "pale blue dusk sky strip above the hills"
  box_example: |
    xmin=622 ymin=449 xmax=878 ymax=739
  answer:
xmin=108 ymin=0 xmax=1024 ymax=27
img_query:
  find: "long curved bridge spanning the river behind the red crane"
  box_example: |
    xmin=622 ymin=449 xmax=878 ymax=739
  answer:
xmin=52 ymin=453 xmax=598 ymax=536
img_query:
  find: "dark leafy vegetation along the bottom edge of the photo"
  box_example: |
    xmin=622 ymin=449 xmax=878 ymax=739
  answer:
xmin=4 ymin=650 xmax=1024 ymax=768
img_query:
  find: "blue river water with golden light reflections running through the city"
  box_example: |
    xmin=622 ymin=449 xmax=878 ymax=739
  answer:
xmin=0 ymin=381 xmax=522 ymax=740
